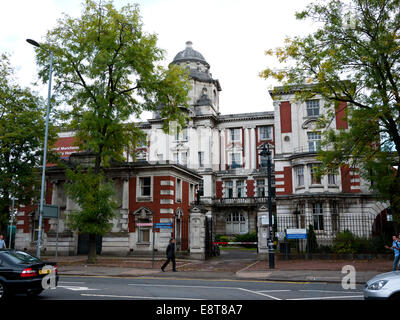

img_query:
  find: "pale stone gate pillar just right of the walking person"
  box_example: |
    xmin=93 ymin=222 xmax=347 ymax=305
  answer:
xmin=189 ymin=205 xmax=207 ymax=260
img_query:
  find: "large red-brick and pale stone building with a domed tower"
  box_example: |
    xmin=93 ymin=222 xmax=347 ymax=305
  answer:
xmin=13 ymin=42 xmax=385 ymax=253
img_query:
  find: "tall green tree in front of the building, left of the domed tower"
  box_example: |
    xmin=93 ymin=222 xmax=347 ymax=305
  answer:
xmin=33 ymin=0 xmax=189 ymax=261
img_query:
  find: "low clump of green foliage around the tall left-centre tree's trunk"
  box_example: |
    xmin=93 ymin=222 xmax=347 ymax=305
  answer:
xmin=65 ymin=168 xmax=117 ymax=235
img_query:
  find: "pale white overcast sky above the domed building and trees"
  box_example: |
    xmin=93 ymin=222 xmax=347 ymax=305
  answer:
xmin=0 ymin=0 xmax=315 ymax=120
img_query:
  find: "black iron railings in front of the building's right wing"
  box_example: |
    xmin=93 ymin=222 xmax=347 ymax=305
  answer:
xmin=275 ymin=215 xmax=379 ymax=251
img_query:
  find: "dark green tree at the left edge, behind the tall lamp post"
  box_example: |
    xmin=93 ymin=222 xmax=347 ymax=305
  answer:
xmin=0 ymin=54 xmax=55 ymax=232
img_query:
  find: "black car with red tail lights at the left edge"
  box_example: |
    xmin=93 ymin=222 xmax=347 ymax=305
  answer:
xmin=0 ymin=249 xmax=58 ymax=301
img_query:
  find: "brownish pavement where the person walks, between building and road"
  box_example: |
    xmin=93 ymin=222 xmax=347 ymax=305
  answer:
xmin=41 ymin=252 xmax=393 ymax=284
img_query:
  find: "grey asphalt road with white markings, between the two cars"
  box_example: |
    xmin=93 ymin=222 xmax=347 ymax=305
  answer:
xmin=9 ymin=276 xmax=363 ymax=301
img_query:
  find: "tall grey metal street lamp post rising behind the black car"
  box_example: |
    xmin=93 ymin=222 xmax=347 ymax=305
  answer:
xmin=26 ymin=39 xmax=53 ymax=258
